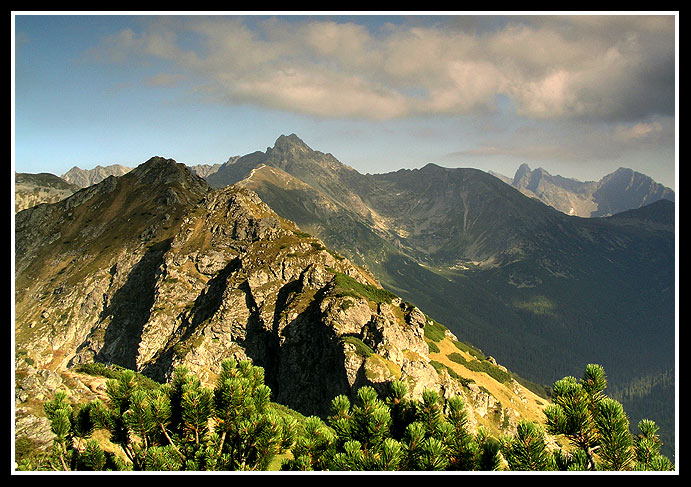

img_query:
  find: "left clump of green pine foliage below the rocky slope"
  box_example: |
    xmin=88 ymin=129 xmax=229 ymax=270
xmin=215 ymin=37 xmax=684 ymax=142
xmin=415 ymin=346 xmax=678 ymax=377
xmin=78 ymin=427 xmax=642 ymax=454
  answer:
xmin=30 ymin=360 xmax=295 ymax=471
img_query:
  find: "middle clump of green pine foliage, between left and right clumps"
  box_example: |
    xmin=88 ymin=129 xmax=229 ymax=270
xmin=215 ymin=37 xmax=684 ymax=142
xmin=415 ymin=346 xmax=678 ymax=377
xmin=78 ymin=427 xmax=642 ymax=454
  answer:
xmin=282 ymin=381 xmax=500 ymax=471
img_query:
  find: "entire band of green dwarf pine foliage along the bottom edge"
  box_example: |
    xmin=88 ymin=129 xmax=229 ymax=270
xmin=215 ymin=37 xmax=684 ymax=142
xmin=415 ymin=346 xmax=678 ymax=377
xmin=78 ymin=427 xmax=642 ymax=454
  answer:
xmin=28 ymin=360 xmax=674 ymax=471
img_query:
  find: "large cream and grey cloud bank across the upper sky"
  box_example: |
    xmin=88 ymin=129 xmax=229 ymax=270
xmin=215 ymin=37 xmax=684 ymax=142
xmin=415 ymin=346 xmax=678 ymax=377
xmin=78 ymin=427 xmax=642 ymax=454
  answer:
xmin=92 ymin=15 xmax=675 ymax=123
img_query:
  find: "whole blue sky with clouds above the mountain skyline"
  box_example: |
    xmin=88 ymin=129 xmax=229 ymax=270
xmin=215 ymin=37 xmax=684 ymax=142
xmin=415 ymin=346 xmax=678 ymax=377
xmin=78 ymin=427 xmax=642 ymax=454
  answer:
xmin=12 ymin=11 xmax=678 ymax=190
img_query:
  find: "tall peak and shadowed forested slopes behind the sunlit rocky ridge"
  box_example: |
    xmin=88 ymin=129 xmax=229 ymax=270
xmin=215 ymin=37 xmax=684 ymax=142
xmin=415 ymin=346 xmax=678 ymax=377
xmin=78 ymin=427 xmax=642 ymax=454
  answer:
xmin=208 ymin=135 xmax=675 ymax=458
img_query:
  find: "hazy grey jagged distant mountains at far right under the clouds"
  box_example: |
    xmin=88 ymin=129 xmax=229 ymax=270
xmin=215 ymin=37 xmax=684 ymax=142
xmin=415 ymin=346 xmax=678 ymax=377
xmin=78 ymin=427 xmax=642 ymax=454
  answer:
xmin=504 ymin=164 xmax=674 ymax=217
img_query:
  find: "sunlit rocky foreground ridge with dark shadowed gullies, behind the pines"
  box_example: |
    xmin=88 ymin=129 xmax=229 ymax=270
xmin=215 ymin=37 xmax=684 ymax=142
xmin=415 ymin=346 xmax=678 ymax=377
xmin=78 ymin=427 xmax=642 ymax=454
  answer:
xmin=15 ymin=157 xmax=547 ymax=446
